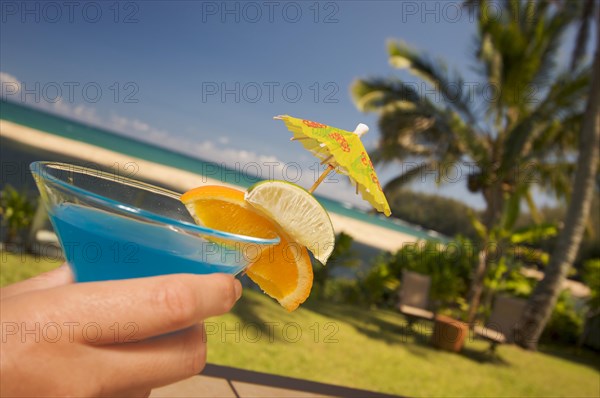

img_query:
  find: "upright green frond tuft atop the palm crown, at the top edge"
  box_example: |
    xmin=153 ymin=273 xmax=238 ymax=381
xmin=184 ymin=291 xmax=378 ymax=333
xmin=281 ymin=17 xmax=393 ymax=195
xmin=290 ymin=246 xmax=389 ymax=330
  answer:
xmin=477 ymin=0 xmax=575 ymax=119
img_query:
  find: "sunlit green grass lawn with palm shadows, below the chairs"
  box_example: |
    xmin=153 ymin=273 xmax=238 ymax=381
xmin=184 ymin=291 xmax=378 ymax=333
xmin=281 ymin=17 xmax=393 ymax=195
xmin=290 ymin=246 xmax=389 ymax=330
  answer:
xmin=1 ymin=250 xmax=600 ymax=397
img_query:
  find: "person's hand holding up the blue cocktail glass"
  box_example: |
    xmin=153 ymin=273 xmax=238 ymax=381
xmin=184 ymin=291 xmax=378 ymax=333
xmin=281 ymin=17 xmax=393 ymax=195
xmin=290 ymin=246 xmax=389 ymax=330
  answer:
xmin=0 ymin=265 xmax=242 ymax=396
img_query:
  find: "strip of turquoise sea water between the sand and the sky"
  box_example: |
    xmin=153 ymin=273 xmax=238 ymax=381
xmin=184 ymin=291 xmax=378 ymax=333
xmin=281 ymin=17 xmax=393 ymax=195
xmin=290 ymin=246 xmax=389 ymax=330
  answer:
xmin=0 ymin=101 xmax=443 ymax=240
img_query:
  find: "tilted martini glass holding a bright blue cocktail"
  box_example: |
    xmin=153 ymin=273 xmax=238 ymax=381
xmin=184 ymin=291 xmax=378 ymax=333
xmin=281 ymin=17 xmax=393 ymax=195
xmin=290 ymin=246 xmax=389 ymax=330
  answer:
xmin=30 ymin=162 xmax=279 ymax=282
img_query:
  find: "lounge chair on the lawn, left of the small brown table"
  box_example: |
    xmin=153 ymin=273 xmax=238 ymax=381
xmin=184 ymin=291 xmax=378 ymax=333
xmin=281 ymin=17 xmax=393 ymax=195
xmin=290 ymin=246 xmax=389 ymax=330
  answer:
xmin=397 ymin=271 xmax=435 ymax=326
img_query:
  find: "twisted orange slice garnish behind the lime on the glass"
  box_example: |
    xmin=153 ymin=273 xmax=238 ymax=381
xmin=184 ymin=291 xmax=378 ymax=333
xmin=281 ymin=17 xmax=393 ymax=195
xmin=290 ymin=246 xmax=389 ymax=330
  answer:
xmin=181 ymin=185 xmax=313 ymax=311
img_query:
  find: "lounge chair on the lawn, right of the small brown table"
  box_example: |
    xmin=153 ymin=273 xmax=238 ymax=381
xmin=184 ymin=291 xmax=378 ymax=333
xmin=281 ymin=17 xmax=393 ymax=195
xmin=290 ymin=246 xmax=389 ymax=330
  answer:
xmin=473 ymin=296 xmax=527 ymax=352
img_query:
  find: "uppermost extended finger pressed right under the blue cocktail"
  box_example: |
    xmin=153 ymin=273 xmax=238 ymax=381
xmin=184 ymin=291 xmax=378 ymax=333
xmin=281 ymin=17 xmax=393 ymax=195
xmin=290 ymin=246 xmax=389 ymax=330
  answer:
xmin=14 ymin=274 xmax=241 ymax=344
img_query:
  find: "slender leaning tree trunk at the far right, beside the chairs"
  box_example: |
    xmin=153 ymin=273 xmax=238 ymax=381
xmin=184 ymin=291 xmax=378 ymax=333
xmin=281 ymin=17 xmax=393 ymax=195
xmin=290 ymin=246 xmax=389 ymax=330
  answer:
xmin=515 ymin=22 xmax=600 ymax=350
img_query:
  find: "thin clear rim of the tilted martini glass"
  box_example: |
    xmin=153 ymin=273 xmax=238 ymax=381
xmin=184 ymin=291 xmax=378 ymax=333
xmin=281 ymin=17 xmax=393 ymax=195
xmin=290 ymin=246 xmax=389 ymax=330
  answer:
xmin=29 ymin=161 xmax=281 ymax=245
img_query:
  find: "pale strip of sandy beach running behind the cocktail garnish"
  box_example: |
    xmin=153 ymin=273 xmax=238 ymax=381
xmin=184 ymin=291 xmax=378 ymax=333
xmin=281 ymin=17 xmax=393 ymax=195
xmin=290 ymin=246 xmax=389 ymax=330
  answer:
xmin=0 ymin=120 xmax=417 ymax=251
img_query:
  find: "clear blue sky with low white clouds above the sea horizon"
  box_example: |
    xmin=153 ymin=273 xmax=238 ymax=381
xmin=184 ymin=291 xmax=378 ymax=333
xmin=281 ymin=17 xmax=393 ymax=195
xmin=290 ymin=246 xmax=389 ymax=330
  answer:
xmin=0 ymin=1 xmax=584 ymax=207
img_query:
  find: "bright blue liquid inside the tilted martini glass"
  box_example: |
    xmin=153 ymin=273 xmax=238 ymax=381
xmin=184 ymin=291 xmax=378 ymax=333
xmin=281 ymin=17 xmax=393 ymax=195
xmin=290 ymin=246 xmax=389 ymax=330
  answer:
xmin=49 ymin=203 xmax=247 ymax=282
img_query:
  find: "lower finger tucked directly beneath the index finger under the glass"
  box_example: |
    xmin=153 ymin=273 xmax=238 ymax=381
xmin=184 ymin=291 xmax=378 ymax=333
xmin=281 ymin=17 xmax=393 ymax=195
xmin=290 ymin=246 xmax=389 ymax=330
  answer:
xmin=93 ymin=324 xmax=206 ymax=391
